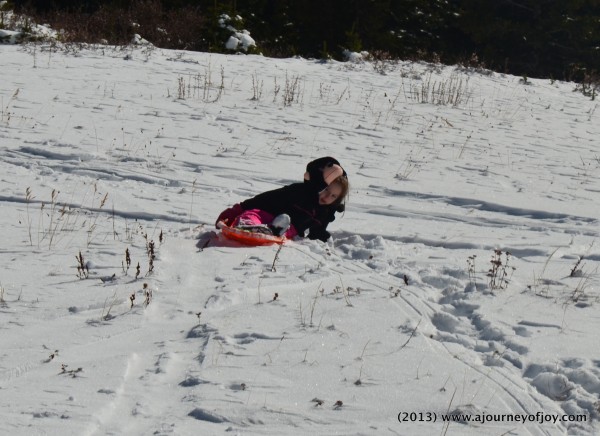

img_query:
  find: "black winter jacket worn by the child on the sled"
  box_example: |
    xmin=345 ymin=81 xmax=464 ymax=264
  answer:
xmin=240 ymin=183 xmax=336 ymax=241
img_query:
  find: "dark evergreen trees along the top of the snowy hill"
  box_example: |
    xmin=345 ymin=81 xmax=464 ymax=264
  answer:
xmin=13 ymin=0 xmax=600 ymax=80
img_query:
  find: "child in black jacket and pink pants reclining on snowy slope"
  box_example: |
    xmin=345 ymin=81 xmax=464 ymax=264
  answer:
xmin=217 ymin=157 xmax=349 ymax=242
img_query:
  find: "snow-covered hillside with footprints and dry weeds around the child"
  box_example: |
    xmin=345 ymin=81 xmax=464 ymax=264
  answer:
xmin=0 ymin=41 xmax=600 ymax=435
